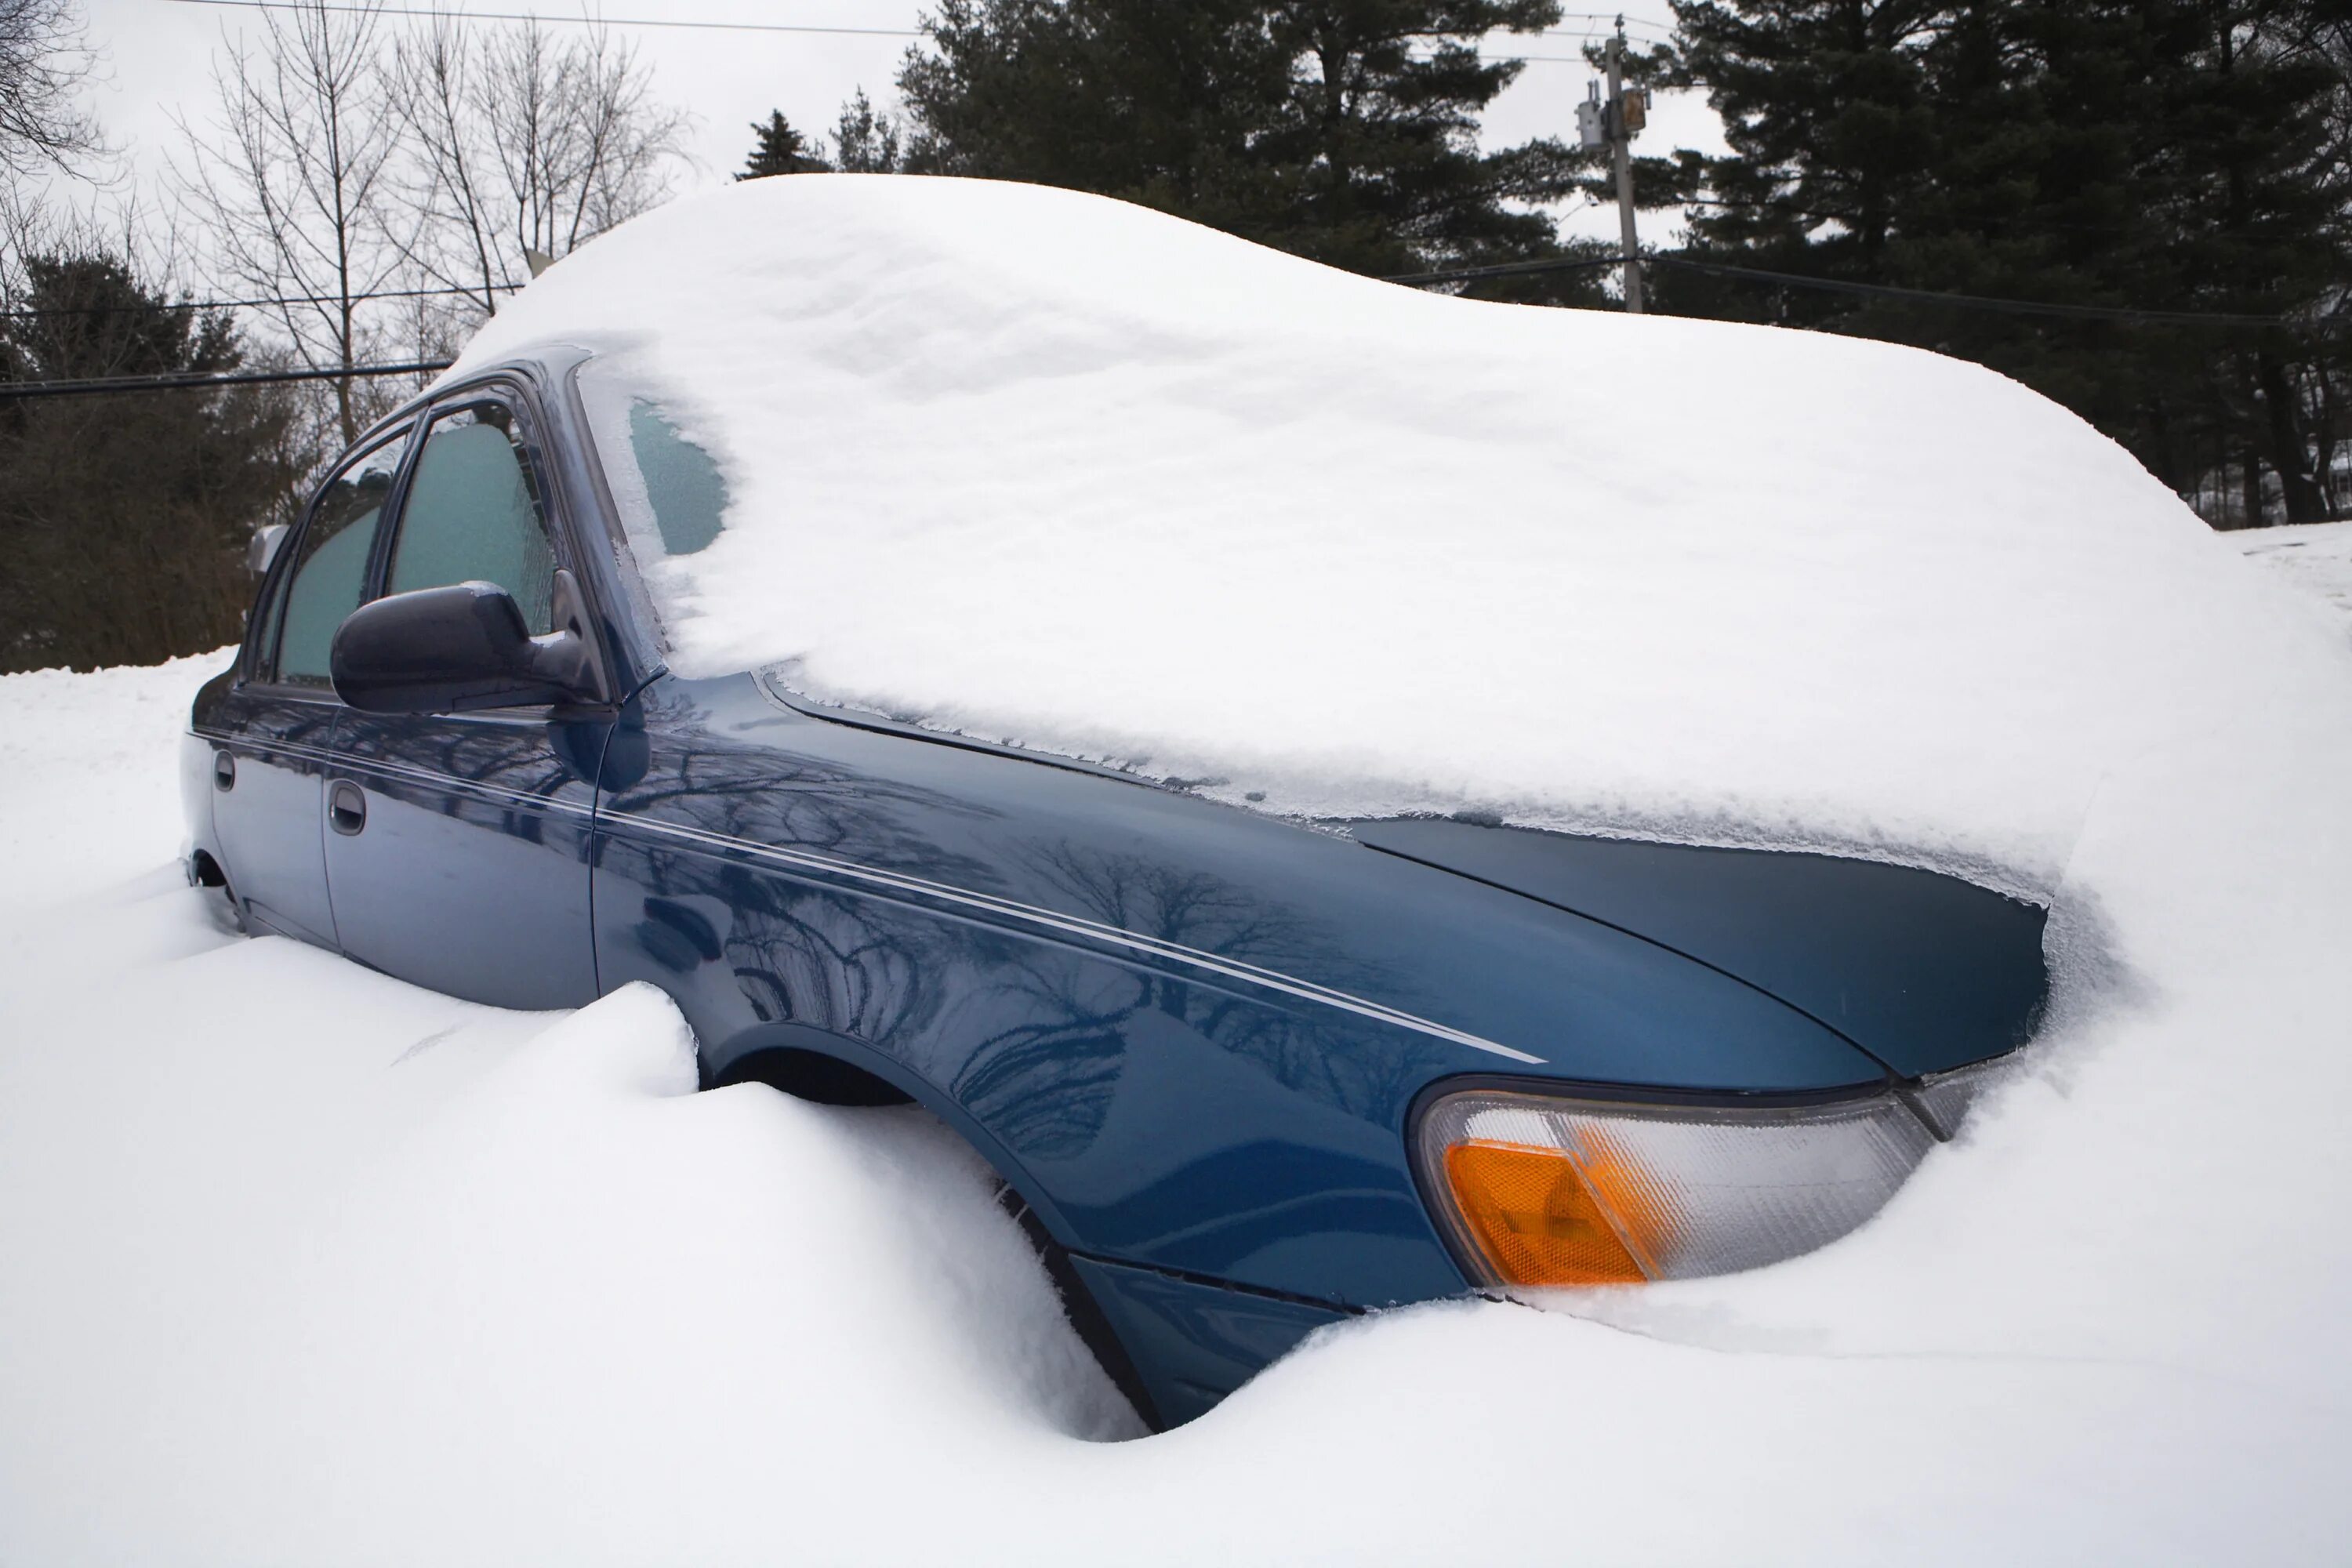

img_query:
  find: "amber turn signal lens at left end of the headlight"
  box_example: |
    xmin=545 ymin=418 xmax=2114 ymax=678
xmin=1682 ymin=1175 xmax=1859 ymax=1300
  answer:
xmin=1446 ymin=1142 xmax=1649 ymax=1286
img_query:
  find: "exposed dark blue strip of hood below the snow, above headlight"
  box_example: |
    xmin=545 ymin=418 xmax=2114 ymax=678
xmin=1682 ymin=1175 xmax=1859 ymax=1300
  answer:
xmin=1352 ymin=818 xmax=2049 ymax=1076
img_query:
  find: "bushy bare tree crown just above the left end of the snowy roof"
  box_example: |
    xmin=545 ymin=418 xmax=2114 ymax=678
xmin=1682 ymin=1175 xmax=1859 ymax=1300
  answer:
xmin=395 ymin=16 xmax=689 ymax=310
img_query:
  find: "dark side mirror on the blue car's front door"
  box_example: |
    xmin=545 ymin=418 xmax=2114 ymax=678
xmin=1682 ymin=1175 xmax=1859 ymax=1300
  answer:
xmin=327 ymin=572 xmax=607 ymax=713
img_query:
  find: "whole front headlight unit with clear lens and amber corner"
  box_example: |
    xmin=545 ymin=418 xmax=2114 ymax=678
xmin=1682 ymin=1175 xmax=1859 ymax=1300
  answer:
xmin=1418 ymin=1086 xmax=1983 ymax=1286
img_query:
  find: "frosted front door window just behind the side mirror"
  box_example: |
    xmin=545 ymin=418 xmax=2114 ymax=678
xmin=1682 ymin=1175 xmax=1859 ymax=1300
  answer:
xmin=386 ymin=400 xmax=555 ymax=637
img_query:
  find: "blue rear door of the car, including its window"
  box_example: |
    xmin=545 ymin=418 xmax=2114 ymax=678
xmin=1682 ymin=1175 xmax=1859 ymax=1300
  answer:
xmin=209 ymin=426 xmax=412 ymax=947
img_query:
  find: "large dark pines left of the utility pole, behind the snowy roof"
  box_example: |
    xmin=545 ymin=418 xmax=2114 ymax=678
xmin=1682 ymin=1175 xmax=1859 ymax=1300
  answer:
xmin=898 ymin=0 xmax=1576 ymax=273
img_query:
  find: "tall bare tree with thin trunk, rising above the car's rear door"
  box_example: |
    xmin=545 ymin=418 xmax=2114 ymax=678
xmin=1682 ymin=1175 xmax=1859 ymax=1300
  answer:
xmin=172 ymin=0 xmax=409 ymax=445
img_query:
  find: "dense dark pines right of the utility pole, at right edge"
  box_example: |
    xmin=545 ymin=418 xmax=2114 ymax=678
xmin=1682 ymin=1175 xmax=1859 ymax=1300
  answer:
xmin=1658 ymin=0 xmax=2352 ymax=520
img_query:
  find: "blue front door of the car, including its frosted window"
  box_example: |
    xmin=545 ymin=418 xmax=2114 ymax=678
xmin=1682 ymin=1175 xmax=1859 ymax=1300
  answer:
xmin=325 ymin=383 xmax=612 ymax=1008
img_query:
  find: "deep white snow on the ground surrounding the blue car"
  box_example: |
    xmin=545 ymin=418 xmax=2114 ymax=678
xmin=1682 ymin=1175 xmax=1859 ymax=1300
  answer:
xmin=0 ymin=543 xmax=2352 ymax=1563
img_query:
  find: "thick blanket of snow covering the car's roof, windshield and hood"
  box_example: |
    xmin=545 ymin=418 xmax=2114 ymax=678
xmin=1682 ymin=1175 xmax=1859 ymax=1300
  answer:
xmin=452 ymin=176 xmax=2324 ymax=891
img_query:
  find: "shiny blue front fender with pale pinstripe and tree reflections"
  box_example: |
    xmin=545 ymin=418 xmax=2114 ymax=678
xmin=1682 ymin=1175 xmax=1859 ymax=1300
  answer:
xmin=595 ymin=677 xmax=1884 ymax=1305
